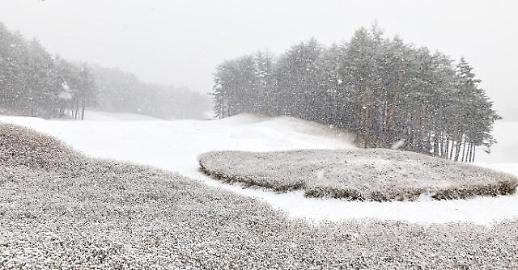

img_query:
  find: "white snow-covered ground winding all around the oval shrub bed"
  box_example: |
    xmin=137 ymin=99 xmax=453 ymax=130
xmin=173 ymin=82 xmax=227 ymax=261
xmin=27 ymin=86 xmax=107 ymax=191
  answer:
xmin=0 ymin=113 xmax=518 ymax=225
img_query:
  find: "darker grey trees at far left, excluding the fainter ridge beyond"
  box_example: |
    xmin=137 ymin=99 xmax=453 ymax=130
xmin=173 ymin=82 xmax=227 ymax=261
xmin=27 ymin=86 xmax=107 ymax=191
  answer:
xmin=0 ymin=23 xmax=95 ymax=119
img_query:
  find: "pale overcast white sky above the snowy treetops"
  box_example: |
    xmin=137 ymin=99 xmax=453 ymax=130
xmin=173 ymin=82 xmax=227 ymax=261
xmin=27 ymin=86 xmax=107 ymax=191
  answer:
xmin=0 ymin=0 xmax=518 ymax=119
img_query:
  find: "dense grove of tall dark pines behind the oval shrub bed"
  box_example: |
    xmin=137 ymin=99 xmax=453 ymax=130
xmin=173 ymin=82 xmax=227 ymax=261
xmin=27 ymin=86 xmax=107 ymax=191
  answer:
xmin=213 ymin=26 xmax=500 ymax=162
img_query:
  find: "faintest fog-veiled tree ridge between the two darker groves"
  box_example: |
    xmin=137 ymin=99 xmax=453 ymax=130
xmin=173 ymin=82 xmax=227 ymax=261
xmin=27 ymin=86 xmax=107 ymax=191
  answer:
xmin=89 ymin=65 xmax=210 ymax=118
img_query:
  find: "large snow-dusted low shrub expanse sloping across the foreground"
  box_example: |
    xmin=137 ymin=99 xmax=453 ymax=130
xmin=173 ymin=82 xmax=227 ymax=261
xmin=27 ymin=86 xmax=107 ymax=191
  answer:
xmin=0 ymin=125 xmax=518 ymax=269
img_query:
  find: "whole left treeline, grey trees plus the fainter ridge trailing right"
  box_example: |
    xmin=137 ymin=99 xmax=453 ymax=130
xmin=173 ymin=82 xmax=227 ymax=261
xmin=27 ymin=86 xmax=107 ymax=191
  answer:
xmin=0 ymin=23 xmax=210 ymax=119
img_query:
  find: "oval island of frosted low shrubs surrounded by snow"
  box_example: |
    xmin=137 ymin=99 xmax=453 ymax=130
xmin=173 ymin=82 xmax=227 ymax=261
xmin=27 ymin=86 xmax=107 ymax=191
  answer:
xmin=199 ymin=149 xmax=518 ymax=201
